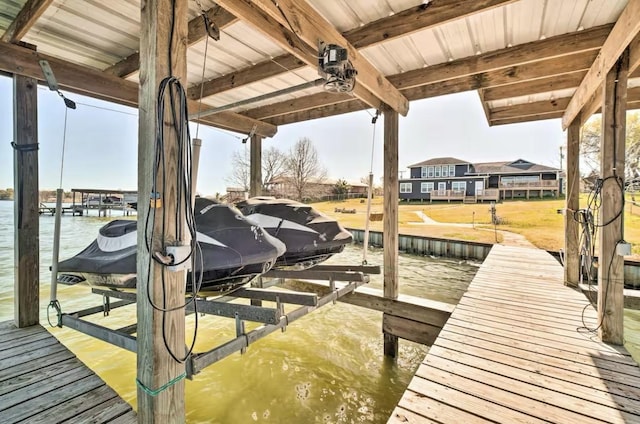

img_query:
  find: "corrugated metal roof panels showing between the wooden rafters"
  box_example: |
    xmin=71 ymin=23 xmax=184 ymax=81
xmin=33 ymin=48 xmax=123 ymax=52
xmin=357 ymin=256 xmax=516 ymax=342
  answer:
xmin=0 ymin=0 xmax=635 ymax=126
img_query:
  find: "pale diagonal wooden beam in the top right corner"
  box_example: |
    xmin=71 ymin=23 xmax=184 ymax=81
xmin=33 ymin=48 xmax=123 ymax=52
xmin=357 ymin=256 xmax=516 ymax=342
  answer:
xmin=562 ymin=0 xmax=640 ymax=129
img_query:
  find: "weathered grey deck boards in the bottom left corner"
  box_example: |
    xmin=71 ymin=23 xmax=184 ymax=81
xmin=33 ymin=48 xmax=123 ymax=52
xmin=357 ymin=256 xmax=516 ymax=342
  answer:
xmin=0 ymin=322 xmax=136 ymax=424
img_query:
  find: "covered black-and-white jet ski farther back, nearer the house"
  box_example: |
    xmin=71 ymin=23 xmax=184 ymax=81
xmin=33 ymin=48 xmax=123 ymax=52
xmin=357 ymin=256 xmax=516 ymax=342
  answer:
xmin=236 ymin=197 xmax=353 ymax=269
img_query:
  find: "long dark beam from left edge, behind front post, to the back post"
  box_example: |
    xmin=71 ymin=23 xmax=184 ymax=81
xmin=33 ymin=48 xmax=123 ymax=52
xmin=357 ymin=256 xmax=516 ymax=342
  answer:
xmin=0 ymin=42 xmax=277 ymax=137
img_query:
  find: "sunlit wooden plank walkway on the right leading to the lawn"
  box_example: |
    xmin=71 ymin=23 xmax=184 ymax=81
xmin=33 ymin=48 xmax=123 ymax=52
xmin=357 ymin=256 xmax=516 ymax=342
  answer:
xmin=389 ymin=245 xmax=640 ymax=424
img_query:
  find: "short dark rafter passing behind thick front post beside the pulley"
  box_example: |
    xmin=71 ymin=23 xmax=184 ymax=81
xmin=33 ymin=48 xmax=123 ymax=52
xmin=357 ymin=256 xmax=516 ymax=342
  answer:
xmin=104 ymin=6 xmax=237 ymax=78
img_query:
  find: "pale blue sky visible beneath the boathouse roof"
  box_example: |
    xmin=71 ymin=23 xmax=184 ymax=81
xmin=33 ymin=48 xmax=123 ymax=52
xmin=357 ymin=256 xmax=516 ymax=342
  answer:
xmin=0 ymin=77 xmax=565 ymax=195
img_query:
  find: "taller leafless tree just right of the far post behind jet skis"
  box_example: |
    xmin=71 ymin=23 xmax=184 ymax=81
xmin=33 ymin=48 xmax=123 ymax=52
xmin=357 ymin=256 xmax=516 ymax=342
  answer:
xmin=285 ymin=137 xmax=326 ymax=200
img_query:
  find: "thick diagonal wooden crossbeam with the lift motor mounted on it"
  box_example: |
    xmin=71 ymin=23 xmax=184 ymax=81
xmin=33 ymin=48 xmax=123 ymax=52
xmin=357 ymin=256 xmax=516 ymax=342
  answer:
xmin=218 ymin=0 xmax=409 ymax=115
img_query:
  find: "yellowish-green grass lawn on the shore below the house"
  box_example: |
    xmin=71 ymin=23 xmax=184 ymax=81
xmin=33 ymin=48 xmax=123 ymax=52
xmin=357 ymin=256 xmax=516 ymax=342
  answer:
xmin=313 ymin=195 xmax=640 ymax=259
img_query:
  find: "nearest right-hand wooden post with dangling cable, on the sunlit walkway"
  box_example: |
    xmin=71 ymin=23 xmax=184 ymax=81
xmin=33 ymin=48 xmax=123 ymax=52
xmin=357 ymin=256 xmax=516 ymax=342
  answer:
xmin=598 ymin=49 xmax=629 ymax=345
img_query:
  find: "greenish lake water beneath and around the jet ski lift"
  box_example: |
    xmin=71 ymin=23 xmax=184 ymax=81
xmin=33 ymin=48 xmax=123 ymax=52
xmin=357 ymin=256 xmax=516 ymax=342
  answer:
xmin=0 ymin=201 xmax=477 ymax=424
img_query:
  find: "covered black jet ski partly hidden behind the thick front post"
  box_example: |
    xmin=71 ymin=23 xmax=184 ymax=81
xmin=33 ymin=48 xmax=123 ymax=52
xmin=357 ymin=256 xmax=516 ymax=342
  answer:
xmin=58 ymin=198 xmax=285 ymax=293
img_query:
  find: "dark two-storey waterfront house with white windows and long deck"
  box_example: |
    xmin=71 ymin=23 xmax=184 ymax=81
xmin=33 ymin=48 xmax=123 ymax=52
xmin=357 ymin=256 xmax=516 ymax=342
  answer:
xmin=399 ymin=157 xmax=562 ymax=203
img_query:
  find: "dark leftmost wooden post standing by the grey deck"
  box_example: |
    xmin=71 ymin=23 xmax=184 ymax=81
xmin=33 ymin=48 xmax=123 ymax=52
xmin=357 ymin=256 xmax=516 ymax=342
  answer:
xmin=13 ymin=75 xmax=40 ymax=327
